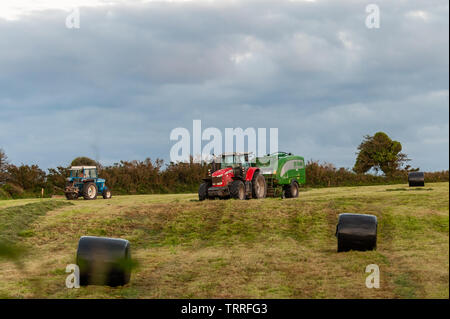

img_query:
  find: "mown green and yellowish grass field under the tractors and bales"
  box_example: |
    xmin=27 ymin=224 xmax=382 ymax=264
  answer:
xmin=0 ymin=183 xmax=449 ymax=298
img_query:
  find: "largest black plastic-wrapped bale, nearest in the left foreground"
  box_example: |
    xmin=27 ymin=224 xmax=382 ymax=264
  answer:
xmin=77 ymin=236 xmax=131 ymax=287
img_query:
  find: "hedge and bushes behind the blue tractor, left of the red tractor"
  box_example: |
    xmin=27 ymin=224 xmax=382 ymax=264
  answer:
xmin=0 ymin=149 xmax=209 ymax=199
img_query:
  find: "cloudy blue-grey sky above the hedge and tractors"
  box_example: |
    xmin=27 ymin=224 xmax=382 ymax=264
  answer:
xmin=0 ymin=0 xmax=449 ymax=171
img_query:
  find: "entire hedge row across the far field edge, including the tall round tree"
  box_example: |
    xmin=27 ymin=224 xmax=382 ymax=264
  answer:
xmin=0 ymin=132 xmax=449 ymax=199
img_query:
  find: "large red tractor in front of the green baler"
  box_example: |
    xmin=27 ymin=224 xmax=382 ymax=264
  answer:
xmin=198 ymin=153 xmax=267 ymax=201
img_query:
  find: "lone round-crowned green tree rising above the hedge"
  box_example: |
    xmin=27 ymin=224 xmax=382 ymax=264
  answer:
xmin=353 ymin=132 xmax=409 ymax=176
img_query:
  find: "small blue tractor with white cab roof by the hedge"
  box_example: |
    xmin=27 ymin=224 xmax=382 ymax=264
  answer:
xmin=64 ymin=166 xmax=111 ymax=200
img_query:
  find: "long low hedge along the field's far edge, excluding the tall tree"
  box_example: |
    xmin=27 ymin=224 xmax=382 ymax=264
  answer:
xmin=0 ymin=158 xmax=449 ymax=199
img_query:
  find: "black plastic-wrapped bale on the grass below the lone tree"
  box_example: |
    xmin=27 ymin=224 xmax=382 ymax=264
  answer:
xmin=336 ymin=214 xmax=378 ymax=252
